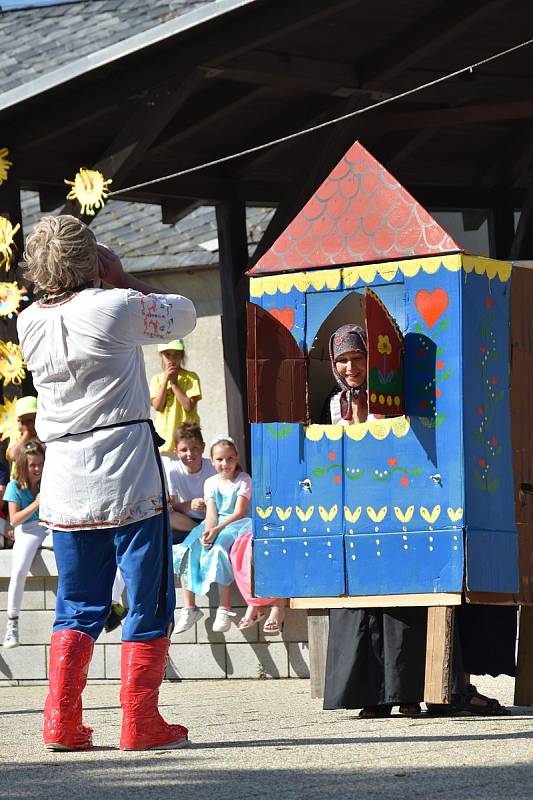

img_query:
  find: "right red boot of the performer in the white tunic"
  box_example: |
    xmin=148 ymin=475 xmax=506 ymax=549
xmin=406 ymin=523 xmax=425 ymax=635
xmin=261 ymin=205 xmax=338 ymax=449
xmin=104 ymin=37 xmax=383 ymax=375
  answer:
xmin=120 ymin=637 xmax=189 ymax=750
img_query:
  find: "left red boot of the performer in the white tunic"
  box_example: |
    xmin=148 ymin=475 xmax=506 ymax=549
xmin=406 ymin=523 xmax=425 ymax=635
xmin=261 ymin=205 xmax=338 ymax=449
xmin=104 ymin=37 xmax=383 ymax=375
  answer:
xmin=44 ymin=629 xmax=94 ymax=750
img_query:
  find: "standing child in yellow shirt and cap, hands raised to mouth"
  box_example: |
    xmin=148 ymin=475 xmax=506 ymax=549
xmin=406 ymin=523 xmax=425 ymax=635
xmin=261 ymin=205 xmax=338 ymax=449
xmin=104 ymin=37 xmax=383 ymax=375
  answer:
xmin=150 ymin=339 xmax=202 ymax=455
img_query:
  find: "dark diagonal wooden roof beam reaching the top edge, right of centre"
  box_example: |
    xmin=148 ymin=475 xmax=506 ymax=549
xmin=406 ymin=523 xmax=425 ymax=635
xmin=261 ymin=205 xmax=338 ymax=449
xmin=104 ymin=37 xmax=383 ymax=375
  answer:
xmin=357 ymin=0 xmax=509 ymax=88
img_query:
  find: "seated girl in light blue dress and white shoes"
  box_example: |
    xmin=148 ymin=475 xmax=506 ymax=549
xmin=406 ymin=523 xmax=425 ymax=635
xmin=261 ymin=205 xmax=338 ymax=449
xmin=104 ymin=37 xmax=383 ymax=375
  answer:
xmin=174 ymin=437 xmax=252 ymax=633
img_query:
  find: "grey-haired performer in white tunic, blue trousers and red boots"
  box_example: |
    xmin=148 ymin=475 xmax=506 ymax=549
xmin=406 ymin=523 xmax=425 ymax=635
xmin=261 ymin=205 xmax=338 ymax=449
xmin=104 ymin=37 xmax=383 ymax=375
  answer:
xmin=18 ymin=215 xmax=196 ymax=750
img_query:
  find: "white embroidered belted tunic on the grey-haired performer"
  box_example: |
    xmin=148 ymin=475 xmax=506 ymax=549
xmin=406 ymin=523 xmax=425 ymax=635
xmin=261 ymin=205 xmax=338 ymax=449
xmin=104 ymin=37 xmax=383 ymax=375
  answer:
xmin=17 ymin=289 xmax=196 ymax=530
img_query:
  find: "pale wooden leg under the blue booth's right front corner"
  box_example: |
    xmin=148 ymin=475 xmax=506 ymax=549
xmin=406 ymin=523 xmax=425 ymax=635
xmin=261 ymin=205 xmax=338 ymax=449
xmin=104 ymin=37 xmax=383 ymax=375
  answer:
xmin=424 ymin=606 xmax=455 ymax=703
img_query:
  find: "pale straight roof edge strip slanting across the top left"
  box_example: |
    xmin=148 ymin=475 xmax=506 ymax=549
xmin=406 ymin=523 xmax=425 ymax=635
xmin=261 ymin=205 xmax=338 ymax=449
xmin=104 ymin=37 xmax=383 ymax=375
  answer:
xmin=0 ymin=0 xmax=256 ymax=111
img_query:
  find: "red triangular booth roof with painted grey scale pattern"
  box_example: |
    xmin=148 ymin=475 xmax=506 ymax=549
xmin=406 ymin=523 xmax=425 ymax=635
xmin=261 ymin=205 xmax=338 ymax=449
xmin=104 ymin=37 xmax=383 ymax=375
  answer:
xmin=248 ymin=142 xmax=463 ymax=275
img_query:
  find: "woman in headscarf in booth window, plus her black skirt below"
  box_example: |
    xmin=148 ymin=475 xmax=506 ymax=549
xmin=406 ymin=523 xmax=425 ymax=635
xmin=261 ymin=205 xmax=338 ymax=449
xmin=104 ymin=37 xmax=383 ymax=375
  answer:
xmin=324 ymin=324 xmax=427 ymax=718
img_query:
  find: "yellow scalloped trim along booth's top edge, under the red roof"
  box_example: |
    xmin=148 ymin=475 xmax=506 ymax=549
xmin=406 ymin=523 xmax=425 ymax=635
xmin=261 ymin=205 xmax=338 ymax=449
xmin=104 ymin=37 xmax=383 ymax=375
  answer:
xmin=250 ymin=253 xmax=512 ymax=297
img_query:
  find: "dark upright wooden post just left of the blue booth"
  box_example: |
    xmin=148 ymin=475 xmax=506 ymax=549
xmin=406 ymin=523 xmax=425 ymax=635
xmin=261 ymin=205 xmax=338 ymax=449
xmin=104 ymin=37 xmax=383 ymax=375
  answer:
xmin=216 ymin=202 xmax=250 ymax=469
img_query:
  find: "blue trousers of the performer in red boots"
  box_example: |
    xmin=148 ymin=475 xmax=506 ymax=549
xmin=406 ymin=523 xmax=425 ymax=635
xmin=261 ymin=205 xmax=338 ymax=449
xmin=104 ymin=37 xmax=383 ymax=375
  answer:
xmin=53 ymin=514 xmax=176 ymax=642
